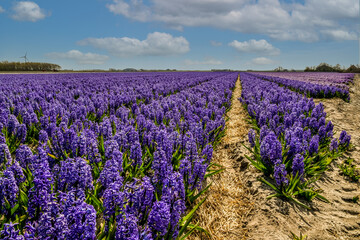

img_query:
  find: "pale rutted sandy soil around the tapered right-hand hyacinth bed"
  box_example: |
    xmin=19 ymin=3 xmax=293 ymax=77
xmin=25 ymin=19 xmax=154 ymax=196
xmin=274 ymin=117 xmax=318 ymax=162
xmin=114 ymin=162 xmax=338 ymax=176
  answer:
xmin=235 ymin=76 xmax=360 ymax=240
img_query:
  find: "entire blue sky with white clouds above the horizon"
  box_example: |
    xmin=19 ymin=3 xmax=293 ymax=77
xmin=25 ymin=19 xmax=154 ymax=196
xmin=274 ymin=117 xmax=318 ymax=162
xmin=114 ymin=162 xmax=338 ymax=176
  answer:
xmin=0 ymin=0 xmax=360 ymax=70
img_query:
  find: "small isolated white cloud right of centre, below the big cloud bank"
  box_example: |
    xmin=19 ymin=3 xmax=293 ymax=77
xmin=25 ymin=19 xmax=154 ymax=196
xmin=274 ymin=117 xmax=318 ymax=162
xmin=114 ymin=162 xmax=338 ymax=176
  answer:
xmin=229 ymin=39 xmax=280 ymax=55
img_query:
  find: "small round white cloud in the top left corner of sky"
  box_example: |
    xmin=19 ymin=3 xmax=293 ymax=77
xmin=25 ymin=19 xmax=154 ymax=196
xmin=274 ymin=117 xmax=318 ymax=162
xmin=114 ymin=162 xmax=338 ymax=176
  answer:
xmin=11 ymin=1 xmax=46 ymax=22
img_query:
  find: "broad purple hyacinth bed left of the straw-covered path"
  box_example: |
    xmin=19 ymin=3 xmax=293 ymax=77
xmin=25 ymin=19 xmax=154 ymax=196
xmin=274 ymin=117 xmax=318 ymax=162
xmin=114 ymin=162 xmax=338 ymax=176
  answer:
xmin=0 ymin=72 xmax=238 ymax=239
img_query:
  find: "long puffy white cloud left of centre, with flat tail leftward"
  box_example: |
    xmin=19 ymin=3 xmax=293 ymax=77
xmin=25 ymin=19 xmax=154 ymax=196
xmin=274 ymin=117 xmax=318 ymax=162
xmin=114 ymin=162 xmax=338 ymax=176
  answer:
xmin=78 ymin=32 xmax=190 ymax=57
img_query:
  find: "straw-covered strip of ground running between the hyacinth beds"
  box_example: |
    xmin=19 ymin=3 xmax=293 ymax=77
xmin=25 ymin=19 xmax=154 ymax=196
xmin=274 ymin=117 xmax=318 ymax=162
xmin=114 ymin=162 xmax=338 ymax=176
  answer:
xmin=189 ymin=76 xmax=253 ymax=239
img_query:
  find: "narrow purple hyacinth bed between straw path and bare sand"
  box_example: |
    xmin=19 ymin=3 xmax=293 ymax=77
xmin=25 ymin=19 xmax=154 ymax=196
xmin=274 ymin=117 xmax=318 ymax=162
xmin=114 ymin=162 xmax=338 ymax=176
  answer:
xmin=239 ymin=73 xmax=351 ymax=209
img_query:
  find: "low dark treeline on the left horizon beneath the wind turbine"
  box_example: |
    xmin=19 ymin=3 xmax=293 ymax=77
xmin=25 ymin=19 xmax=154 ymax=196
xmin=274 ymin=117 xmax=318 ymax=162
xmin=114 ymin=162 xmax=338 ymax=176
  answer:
xmin=0 ymin=61 xmax=61 ymax=71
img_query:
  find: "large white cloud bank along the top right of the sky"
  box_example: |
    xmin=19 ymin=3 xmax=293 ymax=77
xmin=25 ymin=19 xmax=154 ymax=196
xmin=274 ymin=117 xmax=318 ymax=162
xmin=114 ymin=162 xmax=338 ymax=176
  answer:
xmin=107 ymin=0 xmax=359 ymax=42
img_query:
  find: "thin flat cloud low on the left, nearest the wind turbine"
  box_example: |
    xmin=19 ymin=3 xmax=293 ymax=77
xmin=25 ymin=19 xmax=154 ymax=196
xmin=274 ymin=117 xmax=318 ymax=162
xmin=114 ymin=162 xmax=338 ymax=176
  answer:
xmin=46 ymin=50 xmax=109 ymax=65
